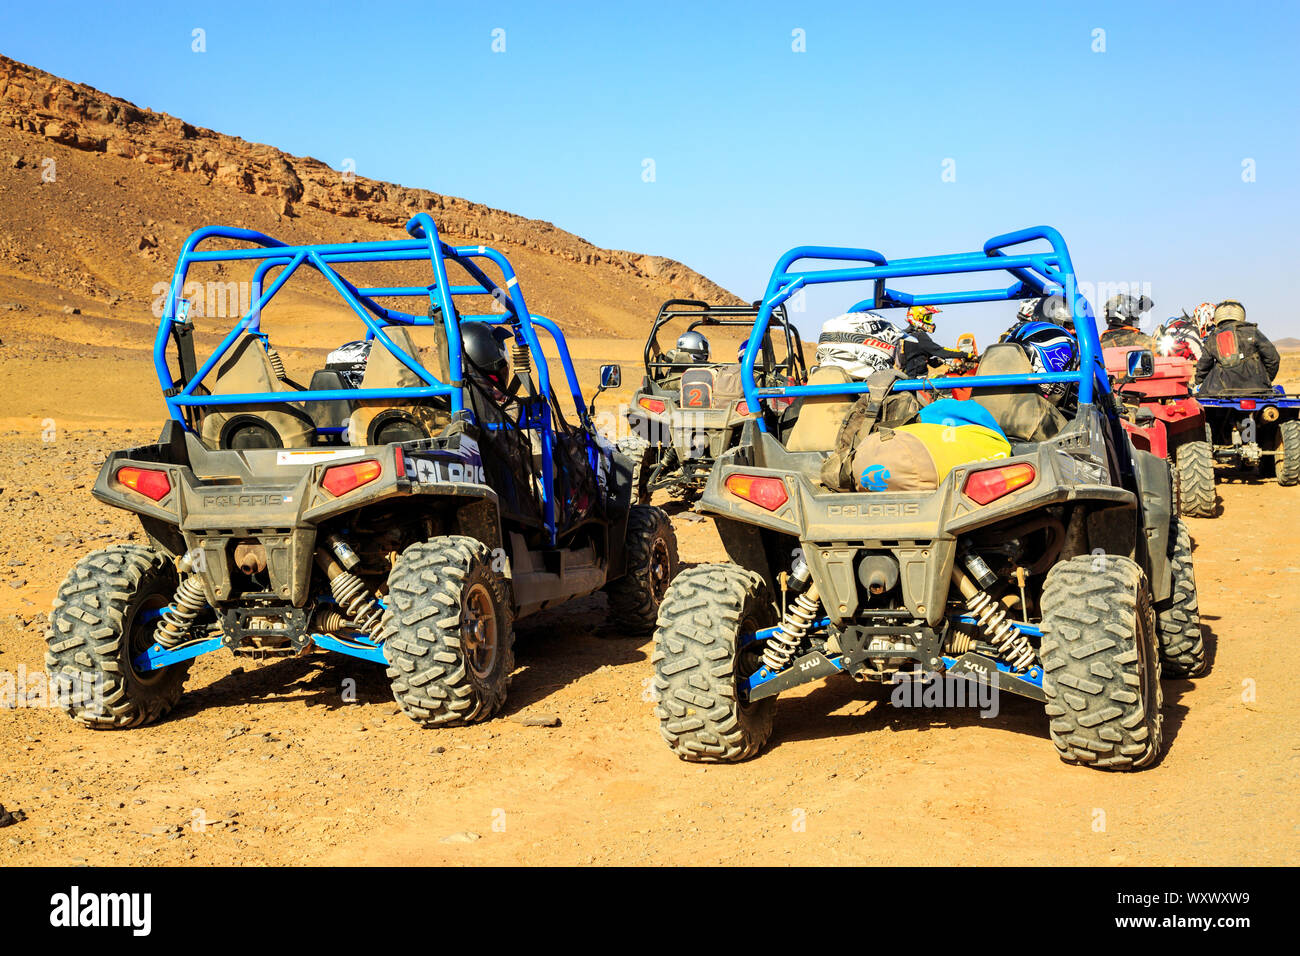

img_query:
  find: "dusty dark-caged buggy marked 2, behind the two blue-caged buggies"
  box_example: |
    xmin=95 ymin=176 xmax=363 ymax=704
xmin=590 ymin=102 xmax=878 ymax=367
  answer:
xmin=619 ymin=299 xmax=807 ymax=505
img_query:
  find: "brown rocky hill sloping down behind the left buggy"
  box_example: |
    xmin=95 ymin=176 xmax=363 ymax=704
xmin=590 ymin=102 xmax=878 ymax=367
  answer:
xmin=0 ymin=56 xmax=737 ymax=336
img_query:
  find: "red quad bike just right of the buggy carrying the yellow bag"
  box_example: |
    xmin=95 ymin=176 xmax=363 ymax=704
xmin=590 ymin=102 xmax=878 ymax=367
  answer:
xmin=1102 ymin=346 xmax=1217 ymax=518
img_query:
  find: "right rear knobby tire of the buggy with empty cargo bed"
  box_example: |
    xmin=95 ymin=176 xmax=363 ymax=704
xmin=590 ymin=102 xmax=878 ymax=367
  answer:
xmin=380 ymin=535 xmax=515 ymax=727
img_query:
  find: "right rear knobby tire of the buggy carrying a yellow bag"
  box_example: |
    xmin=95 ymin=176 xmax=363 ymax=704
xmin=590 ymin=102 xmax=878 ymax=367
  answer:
xmin=1041 ymin=554 xmax=1164 ymax=770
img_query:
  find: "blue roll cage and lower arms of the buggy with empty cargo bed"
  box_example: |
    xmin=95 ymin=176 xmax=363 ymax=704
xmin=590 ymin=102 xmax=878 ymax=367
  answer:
xmin=133 ymin=212 xmax=599 ymax=671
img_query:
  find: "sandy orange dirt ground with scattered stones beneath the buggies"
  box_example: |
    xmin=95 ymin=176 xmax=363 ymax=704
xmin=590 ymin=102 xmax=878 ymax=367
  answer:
xmin=0 ymin=428 xmax=1300 ymax=865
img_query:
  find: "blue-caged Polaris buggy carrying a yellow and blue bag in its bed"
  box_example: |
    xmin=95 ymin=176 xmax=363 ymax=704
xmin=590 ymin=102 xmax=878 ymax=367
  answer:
xmin=654 ymin=226 xmax=1205 ymax=770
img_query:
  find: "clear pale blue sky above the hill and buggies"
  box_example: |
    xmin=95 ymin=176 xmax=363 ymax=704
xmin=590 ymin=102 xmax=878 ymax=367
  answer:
xmin=0 ymin=0 xmax=1300 ymax=338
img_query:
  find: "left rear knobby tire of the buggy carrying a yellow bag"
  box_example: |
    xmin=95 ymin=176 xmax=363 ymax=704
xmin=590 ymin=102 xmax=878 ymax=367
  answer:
xmin=653 ymin=564 xmax=776 ymax=763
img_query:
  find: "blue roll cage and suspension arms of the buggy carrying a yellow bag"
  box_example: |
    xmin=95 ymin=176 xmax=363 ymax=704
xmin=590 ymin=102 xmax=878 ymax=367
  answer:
xmin=740 ymin=226 xmax=1115 ymax=695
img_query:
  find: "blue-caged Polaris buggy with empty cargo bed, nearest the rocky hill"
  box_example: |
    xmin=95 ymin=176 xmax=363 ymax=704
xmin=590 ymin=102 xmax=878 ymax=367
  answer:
xmin=46 ymin=213 xmax=677 ymax=728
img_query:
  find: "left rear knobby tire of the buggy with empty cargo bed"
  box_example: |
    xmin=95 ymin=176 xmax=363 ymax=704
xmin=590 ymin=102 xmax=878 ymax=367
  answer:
xmin=46 ymin=545 xmax=190 ymax=730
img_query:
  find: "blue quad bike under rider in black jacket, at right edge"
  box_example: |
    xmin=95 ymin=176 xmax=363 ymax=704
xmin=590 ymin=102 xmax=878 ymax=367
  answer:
xmin=1196 ymin=385 xmax=1300 ymax=485
